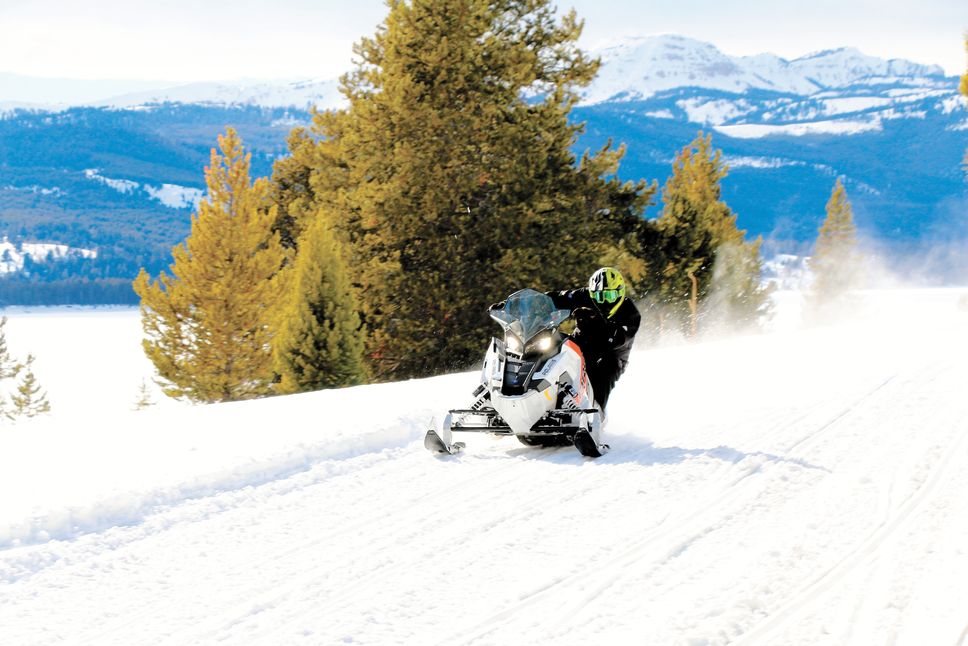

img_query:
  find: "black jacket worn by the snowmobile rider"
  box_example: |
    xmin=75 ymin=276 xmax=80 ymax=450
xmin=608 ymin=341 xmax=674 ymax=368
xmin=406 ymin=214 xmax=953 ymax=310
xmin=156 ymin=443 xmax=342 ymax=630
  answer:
xmin=547 ymin=287 xmax=642 ymax=379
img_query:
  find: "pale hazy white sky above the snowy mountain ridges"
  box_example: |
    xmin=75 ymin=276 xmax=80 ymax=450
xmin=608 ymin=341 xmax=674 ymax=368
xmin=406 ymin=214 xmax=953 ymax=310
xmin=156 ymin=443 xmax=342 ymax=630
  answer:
xmin=0 ymin=0 xmax=968 ymax=81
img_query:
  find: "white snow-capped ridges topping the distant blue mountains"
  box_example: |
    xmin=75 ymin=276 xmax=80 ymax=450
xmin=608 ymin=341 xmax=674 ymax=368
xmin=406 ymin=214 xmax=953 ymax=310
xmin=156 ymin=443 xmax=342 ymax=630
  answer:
xmin=0 ymin=35 xmax=950 ymax=110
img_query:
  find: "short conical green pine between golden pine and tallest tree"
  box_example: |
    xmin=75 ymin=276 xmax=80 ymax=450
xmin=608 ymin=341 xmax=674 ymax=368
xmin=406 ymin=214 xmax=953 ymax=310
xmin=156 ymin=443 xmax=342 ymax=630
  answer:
xmin=274 ymin=211 xmax=366 ymax=392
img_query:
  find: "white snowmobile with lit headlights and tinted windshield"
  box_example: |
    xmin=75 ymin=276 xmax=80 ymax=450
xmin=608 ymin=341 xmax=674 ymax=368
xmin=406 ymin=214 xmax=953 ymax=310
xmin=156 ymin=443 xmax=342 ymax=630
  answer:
xmin=424 ymin=289 xmax=608 ymax=457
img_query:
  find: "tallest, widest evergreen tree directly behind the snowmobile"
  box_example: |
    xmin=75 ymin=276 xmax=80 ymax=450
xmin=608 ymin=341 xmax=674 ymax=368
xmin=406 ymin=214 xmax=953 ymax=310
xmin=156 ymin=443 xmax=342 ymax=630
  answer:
xmin=274 ymin=0 xmax=654 ymax=378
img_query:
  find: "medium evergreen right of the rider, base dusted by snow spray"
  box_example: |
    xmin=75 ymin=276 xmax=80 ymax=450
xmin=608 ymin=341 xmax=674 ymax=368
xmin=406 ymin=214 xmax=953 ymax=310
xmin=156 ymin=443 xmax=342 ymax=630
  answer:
xmin=655 ymin=132 xmax=768 ymax=335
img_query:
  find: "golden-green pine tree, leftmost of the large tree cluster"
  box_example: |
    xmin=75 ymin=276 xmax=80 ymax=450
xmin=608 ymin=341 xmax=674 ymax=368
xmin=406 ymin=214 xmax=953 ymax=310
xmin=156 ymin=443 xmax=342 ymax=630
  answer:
xmin=134 ymin=128 xmax=286 ymax=402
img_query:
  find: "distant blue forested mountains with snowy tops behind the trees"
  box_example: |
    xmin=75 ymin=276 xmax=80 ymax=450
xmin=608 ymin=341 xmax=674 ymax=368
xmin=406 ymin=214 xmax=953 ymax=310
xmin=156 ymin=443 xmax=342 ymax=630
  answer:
xmin=0 ymin=36 xmax=968 ymax=303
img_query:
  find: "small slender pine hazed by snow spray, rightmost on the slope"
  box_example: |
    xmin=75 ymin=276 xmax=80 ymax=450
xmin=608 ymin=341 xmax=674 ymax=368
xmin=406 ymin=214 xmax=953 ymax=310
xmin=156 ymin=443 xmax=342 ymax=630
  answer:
xmin=807 ymin=178 xmax=862 ymax=318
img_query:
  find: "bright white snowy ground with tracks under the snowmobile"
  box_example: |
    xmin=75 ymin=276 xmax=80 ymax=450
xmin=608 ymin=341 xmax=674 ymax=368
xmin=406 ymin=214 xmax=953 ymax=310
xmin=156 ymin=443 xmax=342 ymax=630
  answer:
xmin=0 ymin=289 xmax=968 ymax=646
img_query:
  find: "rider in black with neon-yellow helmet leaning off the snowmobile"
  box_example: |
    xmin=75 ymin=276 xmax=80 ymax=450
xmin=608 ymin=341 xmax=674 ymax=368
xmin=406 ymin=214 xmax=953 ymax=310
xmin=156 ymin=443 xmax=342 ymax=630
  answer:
xmin=547 ymin=267 xmax=641 ymax=413
